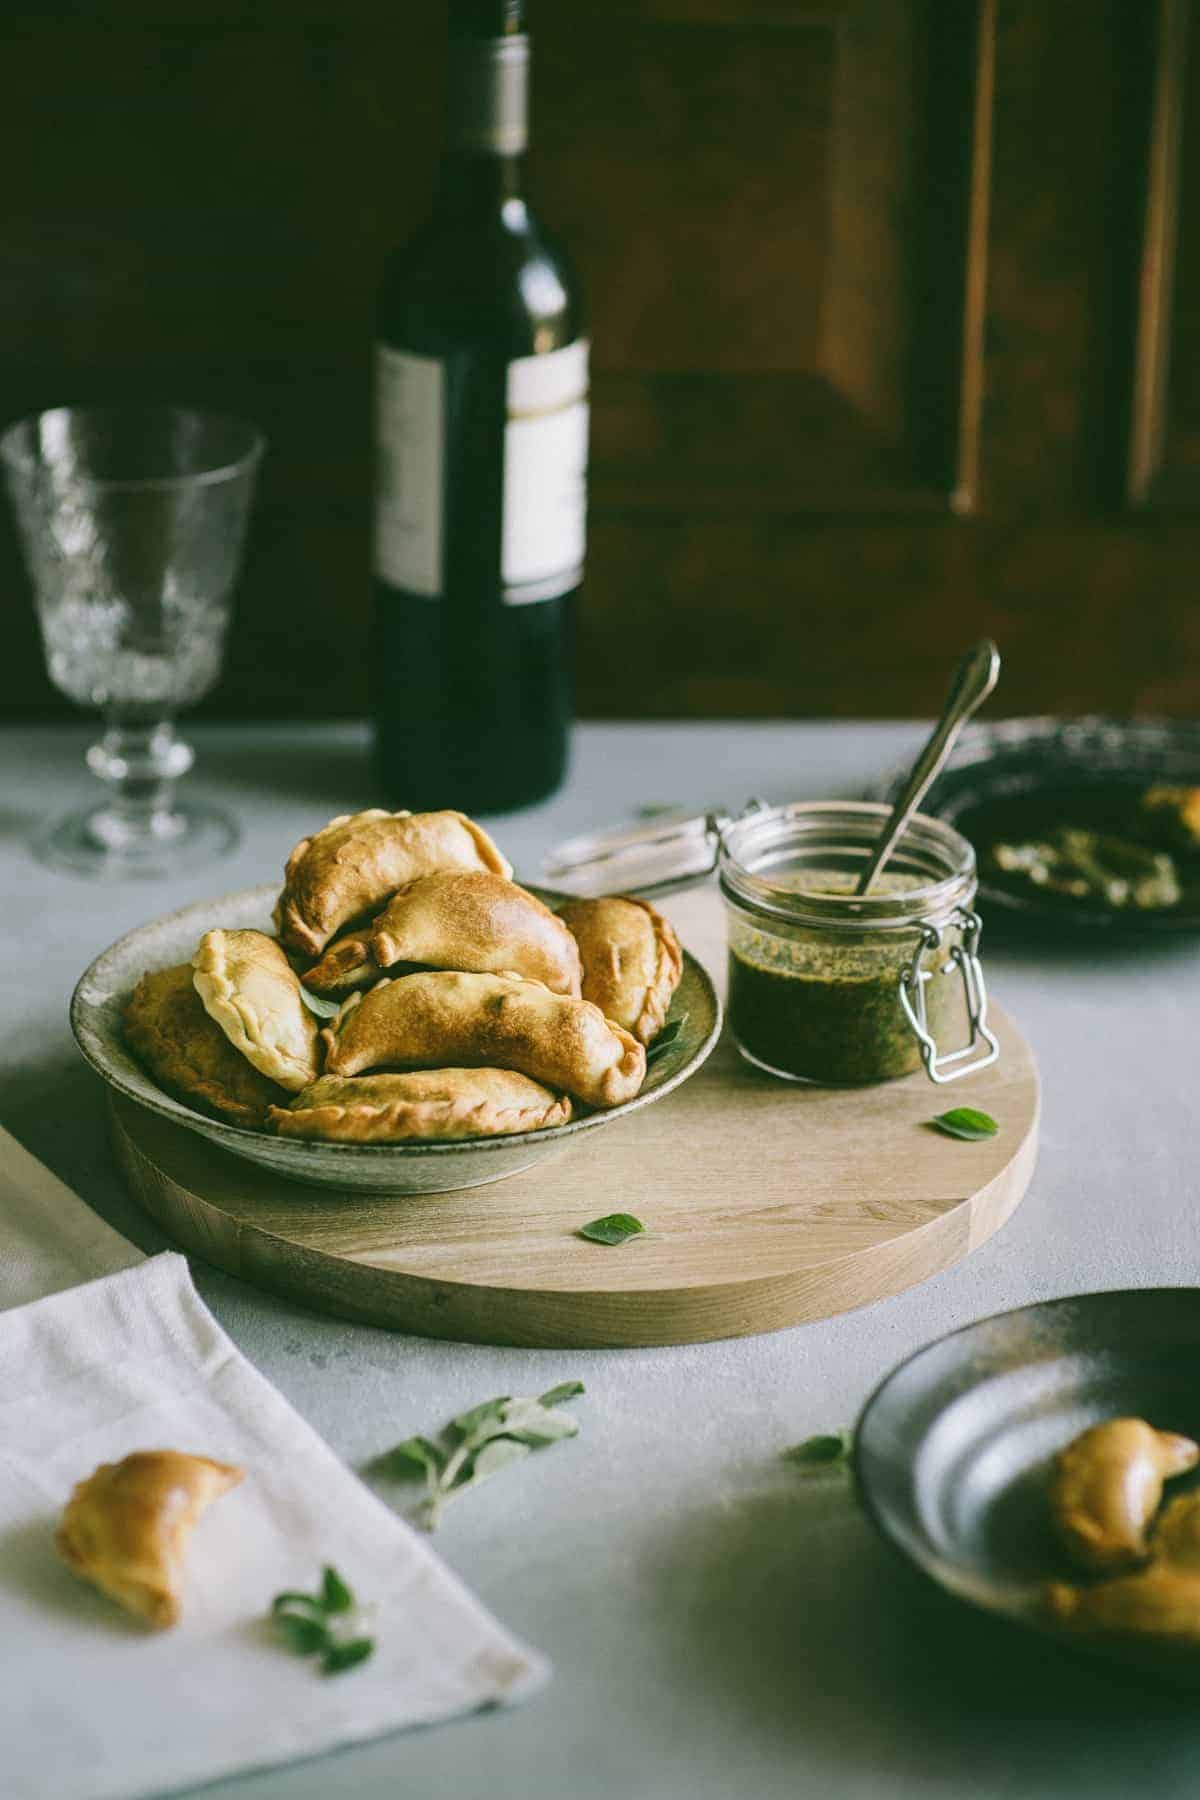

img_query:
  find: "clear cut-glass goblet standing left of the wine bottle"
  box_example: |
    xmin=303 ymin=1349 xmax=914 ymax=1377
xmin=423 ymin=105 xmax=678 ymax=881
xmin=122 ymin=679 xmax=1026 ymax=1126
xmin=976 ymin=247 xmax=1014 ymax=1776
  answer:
xmin=0 ymin=407 xmax=263 ymax=875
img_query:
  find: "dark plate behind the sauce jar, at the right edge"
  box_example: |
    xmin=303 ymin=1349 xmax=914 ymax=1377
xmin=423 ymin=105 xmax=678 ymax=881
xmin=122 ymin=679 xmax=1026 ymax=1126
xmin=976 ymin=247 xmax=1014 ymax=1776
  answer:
xmin=887 ymin=718 xmax=1200 ymax=936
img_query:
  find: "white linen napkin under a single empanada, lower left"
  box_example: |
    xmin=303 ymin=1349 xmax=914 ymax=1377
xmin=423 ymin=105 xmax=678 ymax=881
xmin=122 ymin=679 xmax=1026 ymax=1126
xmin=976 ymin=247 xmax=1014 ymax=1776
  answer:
xmin=0 ymin=1134 xmax=547 ymax=1800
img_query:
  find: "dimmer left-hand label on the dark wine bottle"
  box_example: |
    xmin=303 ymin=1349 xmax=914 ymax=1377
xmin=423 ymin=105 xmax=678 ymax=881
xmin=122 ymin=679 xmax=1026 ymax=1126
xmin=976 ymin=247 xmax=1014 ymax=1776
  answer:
xmin=374 ymin=344 xmax=446 ymax=599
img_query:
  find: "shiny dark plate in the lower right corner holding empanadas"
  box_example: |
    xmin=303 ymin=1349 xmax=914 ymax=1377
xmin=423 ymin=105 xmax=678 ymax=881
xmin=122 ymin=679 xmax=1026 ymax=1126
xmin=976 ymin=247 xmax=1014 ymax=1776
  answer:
xmin=855 ymin=1287 xmax=1200 ymax=1683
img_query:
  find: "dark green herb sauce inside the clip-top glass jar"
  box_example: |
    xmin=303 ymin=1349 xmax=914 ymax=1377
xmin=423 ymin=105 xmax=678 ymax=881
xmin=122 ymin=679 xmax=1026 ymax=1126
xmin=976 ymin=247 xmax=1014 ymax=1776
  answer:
xmin=729 ymin=868 xmax=966 ymax=1085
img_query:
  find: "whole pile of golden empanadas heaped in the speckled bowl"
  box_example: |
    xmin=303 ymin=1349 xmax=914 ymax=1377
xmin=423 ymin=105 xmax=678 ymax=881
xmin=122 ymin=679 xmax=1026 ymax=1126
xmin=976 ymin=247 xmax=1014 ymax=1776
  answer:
xmin=124 ymin=810 xmax=682 ymax=1143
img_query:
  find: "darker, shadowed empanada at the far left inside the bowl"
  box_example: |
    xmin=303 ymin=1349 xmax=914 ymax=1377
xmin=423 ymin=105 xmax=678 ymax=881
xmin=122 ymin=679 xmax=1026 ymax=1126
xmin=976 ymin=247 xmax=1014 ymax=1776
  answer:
xmin=124 ymin=963 xmax=284 ymax=1125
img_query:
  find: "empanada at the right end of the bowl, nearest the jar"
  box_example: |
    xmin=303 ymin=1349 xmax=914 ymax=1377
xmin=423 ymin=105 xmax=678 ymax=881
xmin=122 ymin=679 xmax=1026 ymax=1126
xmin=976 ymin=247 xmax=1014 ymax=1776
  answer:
xmin=558 ymin=895 xmax=684 ymax=1044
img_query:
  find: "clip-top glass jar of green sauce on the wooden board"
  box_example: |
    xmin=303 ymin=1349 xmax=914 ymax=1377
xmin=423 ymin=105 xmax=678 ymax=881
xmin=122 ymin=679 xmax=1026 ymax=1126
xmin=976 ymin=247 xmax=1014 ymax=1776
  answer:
xmin=718 ymin=801 xmax=999 ymax=1085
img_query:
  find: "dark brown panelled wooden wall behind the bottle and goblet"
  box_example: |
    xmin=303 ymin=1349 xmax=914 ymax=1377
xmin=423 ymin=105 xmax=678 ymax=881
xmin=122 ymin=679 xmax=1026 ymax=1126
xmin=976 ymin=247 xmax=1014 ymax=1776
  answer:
xmin=0 ymin=0 xmax=1200 ymax=716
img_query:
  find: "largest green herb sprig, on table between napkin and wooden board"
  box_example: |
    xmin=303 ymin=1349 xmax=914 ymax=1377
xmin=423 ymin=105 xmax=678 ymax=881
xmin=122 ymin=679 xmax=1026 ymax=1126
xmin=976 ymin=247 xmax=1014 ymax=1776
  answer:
xmin=389 ymin=1381 xmax=585 ymax=1532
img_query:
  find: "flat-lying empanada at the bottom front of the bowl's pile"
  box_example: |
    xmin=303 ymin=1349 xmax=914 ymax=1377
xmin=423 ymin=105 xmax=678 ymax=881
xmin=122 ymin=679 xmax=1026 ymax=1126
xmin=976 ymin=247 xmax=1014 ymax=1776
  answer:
xmin=270 ymin=1069 xmax=570 ymax=1143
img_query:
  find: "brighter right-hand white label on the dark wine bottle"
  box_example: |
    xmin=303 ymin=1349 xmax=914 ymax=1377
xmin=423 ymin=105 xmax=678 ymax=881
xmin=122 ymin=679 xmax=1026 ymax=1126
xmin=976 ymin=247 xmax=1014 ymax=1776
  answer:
xmin=500 ymin=338 xmax=588 ymax=605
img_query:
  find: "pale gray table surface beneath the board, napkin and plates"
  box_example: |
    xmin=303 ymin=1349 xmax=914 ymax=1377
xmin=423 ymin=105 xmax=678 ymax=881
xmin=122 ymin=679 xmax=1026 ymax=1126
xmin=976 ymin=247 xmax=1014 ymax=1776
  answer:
xmin=0 ymin=724 xmax=1200 ymax=1800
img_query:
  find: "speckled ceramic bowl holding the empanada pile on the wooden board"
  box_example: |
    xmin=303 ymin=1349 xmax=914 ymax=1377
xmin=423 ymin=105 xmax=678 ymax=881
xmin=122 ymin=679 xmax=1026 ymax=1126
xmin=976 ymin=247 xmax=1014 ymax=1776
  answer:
xmin=70 ymin=886 xmax=721 ymax=1193
